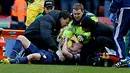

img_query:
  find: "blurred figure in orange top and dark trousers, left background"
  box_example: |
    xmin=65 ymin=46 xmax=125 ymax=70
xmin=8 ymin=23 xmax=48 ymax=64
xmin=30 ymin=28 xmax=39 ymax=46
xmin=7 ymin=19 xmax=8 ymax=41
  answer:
xmin=10 ymin=0 xmax=27 ymax=29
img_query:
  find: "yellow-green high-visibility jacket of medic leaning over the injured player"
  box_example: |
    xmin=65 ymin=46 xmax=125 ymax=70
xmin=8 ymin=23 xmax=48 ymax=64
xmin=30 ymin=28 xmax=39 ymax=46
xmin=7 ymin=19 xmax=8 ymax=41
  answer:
xmin=62 ymin=12 xmax=98 ymax=44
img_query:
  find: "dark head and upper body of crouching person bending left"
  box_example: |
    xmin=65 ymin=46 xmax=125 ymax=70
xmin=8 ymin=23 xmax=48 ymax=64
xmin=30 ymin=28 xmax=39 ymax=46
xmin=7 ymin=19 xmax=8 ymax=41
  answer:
xmin=80 ymin=17 xmax=114 ymax=38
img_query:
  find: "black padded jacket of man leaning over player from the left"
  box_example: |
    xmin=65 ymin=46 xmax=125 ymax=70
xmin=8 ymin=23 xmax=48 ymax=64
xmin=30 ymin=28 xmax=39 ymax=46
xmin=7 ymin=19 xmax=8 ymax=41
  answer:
xmin=24 ymin=10 xmax=61 ymax=51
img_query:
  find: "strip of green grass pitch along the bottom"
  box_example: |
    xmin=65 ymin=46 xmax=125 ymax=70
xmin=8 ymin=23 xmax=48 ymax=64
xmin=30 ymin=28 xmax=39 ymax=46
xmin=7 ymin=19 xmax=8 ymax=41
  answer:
xmin=0 ymin=64 xmax=130 ymax=73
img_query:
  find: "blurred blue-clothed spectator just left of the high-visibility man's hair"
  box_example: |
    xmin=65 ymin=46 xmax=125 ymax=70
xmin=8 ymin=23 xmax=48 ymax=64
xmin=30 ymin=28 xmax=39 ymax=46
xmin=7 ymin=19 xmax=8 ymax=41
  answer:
xmin=60 ymin=0 xmax=78 ymax=13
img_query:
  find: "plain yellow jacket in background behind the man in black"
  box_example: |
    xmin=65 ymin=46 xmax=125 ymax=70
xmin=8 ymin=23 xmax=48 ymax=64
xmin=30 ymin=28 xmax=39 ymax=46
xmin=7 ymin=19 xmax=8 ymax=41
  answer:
xmin=26 ymin=0 xmax=44 ymax=27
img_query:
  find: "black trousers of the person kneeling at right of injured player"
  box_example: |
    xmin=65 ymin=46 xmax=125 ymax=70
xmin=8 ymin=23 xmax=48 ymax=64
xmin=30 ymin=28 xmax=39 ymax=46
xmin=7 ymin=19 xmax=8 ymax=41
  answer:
xmin=79 ymin=36 xmax=115 ymax=65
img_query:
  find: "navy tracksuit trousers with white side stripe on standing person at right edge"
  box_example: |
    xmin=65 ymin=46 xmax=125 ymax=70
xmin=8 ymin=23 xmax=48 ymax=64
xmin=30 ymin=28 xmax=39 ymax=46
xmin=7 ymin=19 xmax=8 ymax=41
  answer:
xmin=114 ymin=7 xmax=130 ymax=58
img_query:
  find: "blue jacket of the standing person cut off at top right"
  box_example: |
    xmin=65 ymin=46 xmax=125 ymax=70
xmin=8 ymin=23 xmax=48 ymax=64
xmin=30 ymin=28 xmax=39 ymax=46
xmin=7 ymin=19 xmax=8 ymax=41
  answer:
xmin=109 ymin=0 xmax=130 ymax=13
